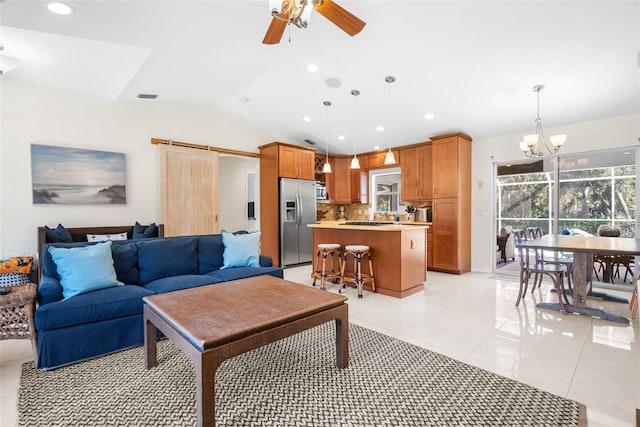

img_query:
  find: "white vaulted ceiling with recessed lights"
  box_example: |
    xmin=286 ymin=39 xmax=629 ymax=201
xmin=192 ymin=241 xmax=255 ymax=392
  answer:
xmin=0 ymin=0 xmax=640 ymax=154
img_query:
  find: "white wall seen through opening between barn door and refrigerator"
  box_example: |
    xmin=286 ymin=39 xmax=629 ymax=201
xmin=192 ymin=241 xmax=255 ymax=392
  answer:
xmin=219 ymin=156 xmax=260 ymax=231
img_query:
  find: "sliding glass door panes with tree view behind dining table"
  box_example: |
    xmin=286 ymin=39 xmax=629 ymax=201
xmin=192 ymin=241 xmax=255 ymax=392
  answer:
xmin=496 ymin=149 xmax=636 ymax=237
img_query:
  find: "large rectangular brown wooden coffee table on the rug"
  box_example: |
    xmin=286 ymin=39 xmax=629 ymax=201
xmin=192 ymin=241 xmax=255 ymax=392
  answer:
xmin=143 ymin=276 xmax=349 ymax=426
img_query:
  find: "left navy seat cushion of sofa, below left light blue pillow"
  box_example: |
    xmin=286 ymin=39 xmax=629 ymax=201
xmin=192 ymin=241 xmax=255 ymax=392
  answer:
xmin=35 ymin=285 xmax=154 ymax=331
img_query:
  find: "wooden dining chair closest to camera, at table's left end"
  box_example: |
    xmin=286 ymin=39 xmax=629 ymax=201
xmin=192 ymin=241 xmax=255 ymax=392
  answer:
xmin=516 ymin=246 xmax=569 ymax=314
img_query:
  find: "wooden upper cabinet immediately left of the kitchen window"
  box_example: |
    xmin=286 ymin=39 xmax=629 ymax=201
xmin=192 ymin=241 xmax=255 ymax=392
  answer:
xmin=326 ymin=157 xmax=369 ymax=203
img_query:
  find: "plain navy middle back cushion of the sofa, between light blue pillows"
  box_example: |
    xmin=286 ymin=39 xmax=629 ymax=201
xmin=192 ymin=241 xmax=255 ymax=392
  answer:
xmin=138 ymin=237 xmax=198 ymax=285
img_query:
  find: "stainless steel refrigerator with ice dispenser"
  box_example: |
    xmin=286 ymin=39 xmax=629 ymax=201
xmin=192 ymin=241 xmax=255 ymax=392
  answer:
xmin=280 ymin=178 xmax=316 ymax=266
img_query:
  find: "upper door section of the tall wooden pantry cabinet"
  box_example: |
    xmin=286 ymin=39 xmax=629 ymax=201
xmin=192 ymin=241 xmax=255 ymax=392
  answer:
xmin=430 ymin=133 xmax=471 ymax=199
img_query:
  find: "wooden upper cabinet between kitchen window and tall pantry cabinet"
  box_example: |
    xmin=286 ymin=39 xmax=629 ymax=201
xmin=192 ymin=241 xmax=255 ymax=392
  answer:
xmin=400 ymin=143 xmax=433 ymax=201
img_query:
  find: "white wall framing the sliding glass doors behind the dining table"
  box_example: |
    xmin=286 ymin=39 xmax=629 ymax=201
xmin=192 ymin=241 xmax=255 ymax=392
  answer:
xmin=471 ymin=114 xmax=640 ymax=272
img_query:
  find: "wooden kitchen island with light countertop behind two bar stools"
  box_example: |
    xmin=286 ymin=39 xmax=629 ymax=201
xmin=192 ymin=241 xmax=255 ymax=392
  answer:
xmin=308 ymin=222 xmax=428 ymax=298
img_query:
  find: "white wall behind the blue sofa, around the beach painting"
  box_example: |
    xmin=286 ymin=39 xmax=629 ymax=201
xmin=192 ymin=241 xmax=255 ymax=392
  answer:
xmin=0 ymin=76 xmax=273 ymax=258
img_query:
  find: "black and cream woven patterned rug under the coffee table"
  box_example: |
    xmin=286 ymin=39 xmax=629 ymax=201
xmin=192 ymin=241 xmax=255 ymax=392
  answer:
xmin=18 ymin=322 xmax=586 ymax=427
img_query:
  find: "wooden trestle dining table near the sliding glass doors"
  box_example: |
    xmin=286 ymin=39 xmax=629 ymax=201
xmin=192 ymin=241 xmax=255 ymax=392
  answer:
xmin=519 ymin=234 xmax=640 ymax=324
